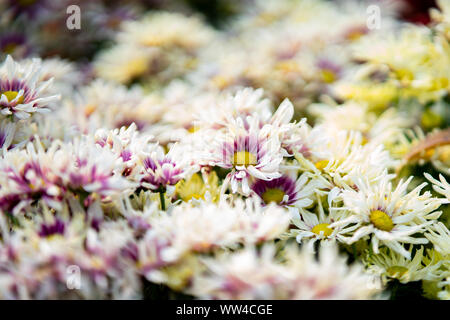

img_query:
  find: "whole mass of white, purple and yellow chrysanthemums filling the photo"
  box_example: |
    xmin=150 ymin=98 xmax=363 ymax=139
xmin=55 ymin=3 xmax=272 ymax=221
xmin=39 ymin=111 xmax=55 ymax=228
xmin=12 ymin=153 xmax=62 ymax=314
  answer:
xmin=0 ymin=0 xmax=450 ymax=299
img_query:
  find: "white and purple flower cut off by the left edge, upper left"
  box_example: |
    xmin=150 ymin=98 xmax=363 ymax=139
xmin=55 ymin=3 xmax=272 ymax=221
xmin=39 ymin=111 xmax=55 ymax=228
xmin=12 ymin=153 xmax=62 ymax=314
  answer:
xmin=0 ymin=56 xmax=59 ymax=119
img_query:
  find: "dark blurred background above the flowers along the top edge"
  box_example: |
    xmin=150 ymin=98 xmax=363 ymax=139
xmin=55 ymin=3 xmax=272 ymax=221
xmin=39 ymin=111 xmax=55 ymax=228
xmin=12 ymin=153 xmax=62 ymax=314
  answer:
xmin=0 ymin=0 xmax=436 ymax=62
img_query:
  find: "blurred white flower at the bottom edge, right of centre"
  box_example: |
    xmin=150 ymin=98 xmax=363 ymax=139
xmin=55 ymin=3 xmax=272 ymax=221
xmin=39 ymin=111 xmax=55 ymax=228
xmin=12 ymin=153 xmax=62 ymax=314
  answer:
xmin=190 ymin=245 xmax=381 ymax=300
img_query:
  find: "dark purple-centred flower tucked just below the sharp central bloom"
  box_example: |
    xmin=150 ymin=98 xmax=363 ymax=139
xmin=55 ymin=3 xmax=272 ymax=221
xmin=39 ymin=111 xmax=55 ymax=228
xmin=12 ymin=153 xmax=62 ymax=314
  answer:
xmin=251 ymin=170 xmax=314 ymax=207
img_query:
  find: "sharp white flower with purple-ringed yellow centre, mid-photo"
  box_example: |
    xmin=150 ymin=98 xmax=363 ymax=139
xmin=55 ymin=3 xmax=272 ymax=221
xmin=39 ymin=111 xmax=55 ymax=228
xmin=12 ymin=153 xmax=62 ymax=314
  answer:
xmin=206 ymin=117 xmax=283 ymax=195
